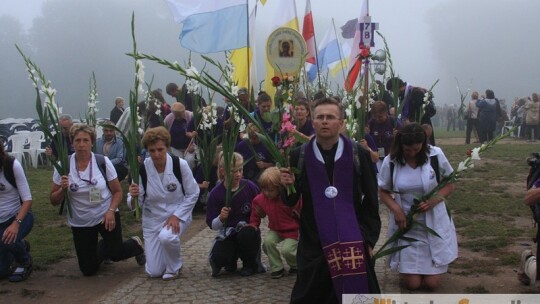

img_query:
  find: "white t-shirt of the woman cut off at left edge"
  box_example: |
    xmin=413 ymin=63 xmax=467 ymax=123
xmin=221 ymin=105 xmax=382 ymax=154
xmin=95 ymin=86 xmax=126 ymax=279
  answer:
xmin=0 ymin=159 xmax=32 ymax=223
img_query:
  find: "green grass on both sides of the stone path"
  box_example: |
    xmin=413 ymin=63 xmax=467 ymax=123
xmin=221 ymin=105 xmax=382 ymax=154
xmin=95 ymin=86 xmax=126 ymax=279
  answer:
xmin=19 ymin=134 xmax=538 ymax=269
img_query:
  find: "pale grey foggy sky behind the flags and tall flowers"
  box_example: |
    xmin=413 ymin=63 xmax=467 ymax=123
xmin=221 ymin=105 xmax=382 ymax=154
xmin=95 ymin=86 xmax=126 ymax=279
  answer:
xmin=0 ymin=0 xmax=540 ymax=119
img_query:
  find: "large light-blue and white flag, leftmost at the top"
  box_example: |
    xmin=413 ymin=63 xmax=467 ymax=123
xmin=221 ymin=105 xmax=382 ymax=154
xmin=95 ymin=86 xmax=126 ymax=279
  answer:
xmin=166 ymin=0 xmax=248 ymax=54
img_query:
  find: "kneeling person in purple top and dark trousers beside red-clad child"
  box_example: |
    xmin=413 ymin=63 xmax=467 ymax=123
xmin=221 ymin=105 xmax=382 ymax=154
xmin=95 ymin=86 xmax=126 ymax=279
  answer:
xmin=206 ymin=152 xmax=264 ymax=277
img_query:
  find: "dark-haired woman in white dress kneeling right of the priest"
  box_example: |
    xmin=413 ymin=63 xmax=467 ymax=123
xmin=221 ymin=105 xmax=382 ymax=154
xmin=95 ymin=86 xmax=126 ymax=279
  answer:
xmin=378 ymin=123 xmax=458 ymax=290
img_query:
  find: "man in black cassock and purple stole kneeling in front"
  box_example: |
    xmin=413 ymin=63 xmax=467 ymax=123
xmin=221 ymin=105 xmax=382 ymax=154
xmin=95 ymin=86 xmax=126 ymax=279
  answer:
xmin=281 ymin=98 xmax=381 ymax=303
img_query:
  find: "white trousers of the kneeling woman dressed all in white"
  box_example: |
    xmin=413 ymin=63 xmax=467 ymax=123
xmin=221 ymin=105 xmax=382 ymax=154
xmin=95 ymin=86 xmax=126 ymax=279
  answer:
xmin=143 ymin=223 xmax=190 ymax=277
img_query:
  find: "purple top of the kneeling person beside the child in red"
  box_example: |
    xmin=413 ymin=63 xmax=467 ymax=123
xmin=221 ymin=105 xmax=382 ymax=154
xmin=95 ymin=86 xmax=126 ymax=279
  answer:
xmin=206 ymin=179 xmax=259 ymax=227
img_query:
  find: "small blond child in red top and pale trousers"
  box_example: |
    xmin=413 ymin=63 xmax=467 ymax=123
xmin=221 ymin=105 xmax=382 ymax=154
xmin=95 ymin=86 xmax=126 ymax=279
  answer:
xmin=249 ymin=167 xmax=302 ymax=279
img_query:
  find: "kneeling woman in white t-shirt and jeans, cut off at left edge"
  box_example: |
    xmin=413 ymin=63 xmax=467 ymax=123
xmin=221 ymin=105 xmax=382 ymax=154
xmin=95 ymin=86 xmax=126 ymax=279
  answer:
xmin=0 ymin=141 xmax=34 ymax=282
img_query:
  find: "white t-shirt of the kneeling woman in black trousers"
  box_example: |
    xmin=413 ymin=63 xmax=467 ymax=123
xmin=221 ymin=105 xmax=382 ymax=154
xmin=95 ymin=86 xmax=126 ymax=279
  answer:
xmin=53 ymin=153 xmax=117 ymax=227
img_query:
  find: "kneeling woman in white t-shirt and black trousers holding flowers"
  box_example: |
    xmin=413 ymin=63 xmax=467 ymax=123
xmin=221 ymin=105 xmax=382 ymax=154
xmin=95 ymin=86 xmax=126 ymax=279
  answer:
xmin=50 ymin=124 xmax=144 ymax=276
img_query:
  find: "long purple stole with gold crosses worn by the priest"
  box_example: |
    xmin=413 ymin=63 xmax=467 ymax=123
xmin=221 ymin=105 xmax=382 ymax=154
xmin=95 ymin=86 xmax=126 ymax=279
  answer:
xmin=305 ymin=136 xmax=369 ymax=303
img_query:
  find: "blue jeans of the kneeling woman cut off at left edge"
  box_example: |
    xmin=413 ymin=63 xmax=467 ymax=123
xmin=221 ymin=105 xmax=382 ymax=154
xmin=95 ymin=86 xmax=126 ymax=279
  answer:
xmin=0 ymin=212 xmax=34 ymax=278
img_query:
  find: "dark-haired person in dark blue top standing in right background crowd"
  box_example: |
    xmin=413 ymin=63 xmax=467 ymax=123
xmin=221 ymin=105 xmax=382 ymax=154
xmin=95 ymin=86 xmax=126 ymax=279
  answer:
xmin=476 ymin=90 xmax=501 ymax=143
